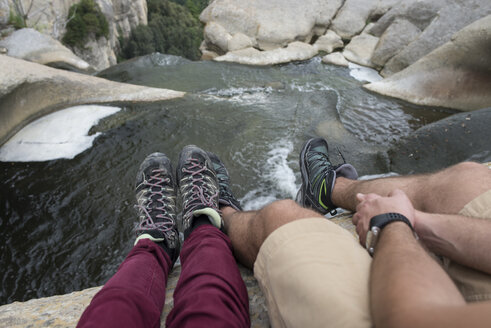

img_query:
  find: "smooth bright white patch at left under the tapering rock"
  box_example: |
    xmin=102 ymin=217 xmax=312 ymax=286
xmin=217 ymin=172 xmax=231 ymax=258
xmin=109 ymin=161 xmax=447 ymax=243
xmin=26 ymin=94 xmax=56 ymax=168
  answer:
xmin=0 ymin=105 xmax=121 ymax=162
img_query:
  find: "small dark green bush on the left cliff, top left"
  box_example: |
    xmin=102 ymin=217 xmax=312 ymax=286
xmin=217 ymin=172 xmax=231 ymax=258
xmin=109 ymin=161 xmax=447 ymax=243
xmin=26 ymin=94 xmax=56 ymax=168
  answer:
xmin=62 ymin=0 xmax=109 ymax=48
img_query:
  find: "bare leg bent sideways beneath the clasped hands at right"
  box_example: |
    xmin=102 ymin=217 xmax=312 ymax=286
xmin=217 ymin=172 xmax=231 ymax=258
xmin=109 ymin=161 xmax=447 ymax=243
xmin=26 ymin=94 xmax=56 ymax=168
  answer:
xmin=332 ymin=162 xmax=491 ymax=214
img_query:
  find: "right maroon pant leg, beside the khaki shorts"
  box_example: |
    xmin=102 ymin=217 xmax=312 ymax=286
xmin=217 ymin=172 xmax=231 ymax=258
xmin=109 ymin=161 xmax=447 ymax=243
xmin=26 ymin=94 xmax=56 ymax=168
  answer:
xmin=166 ymin=225 xmax=250 ymax=327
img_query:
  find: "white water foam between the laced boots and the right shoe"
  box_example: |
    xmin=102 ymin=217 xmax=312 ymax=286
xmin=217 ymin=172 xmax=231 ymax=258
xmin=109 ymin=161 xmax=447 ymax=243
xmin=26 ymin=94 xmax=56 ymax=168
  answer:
xmin=241 ymin=140 xmax=300 ymax=210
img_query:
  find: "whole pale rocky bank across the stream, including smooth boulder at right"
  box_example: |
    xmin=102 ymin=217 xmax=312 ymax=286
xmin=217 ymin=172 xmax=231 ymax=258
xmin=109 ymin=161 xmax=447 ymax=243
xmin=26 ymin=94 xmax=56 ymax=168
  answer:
xmin=200 ymin=0 xmax=491 ymax=110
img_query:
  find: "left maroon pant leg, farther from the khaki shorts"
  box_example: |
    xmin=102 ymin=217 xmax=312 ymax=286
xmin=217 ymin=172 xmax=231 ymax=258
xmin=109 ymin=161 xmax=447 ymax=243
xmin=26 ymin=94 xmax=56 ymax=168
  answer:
xmin=77 ymin=239 xmax=171 ymax=327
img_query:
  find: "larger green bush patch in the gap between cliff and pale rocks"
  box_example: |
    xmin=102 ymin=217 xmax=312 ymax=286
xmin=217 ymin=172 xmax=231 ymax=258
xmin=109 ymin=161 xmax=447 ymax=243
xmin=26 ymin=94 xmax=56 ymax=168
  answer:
xmin=120 ymin=0 xmax=207 ymax=60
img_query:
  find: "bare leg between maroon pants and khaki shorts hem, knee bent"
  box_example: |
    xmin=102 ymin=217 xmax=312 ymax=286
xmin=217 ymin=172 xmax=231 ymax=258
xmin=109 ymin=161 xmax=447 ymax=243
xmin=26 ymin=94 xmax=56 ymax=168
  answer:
xmin=222 ymin=200 xmax=323 ymax=269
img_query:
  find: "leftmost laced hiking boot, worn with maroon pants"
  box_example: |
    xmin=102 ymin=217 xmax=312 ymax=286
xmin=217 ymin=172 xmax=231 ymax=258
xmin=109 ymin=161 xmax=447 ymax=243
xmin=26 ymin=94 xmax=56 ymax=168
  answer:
xmin=135 ymin=153 xmax=180 ymax=263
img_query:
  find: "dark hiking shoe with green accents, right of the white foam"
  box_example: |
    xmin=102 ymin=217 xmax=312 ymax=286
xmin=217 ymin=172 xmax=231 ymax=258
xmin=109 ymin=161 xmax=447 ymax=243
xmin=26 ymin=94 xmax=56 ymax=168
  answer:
xmin=296 ymin=138 xmax=358 ymax=215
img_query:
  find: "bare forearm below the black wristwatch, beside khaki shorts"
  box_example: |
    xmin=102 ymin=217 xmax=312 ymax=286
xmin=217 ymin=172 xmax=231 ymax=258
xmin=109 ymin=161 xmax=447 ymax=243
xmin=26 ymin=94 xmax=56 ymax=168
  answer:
xmin=370 ymin=222 xmax=465 ymax=328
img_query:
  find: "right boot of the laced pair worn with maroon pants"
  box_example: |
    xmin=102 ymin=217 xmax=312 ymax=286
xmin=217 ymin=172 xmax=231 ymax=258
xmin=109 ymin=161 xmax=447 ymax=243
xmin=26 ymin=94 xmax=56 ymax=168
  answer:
xmin=177 ymin=145 xmax=223 ymax=238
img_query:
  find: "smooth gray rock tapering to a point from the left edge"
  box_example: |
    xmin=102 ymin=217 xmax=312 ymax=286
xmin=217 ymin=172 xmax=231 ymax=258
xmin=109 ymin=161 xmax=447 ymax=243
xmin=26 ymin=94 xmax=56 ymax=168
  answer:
xmin=0 ymin=55 xmax=184 ymax=145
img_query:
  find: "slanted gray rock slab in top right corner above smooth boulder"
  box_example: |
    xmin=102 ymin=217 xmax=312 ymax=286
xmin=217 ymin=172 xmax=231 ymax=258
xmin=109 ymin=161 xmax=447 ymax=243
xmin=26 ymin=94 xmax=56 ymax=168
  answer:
xmin=372 ymin=0 xmax=491 ymax=76
